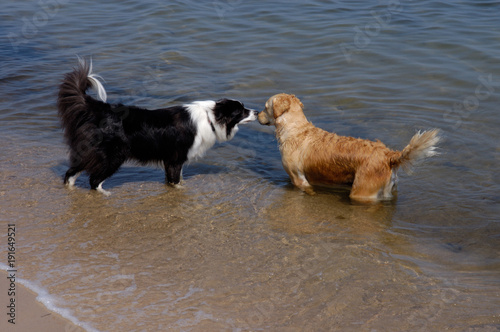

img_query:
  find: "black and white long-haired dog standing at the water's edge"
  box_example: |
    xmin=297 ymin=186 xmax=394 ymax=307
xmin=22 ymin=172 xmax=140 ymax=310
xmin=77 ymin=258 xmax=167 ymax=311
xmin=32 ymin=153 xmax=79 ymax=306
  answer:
xmin=57 ymin=60 xmax=257 ymax=194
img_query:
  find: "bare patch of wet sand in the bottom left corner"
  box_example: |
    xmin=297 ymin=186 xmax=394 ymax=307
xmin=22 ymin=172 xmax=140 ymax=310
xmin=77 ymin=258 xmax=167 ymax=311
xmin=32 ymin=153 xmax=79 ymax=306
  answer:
xmin=0 ymin=270 xmax=86 ymax=332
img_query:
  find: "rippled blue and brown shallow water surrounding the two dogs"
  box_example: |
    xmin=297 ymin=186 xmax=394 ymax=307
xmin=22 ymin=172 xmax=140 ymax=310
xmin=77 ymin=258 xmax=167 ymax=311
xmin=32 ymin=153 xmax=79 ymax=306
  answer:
xmin=0 ymin=1 xmax=500 ymax=331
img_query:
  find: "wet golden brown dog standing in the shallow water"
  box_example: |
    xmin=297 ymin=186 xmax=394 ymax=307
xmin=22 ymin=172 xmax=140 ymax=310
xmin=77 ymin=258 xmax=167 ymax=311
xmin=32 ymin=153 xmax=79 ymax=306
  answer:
xmin=258 ymin=93 xmax=439 ymax=201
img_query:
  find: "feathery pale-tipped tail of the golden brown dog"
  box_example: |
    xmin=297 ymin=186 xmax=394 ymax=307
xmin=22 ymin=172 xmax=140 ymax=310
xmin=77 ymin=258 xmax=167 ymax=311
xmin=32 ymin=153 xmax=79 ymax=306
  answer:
xmin=390 ymin=129 xmax=441 ymax=174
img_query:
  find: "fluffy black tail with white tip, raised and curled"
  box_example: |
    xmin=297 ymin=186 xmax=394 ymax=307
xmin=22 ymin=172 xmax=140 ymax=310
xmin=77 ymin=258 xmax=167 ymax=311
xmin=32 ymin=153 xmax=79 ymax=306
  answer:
xmin=57 ymin=58 xmax=107 ymax=145
